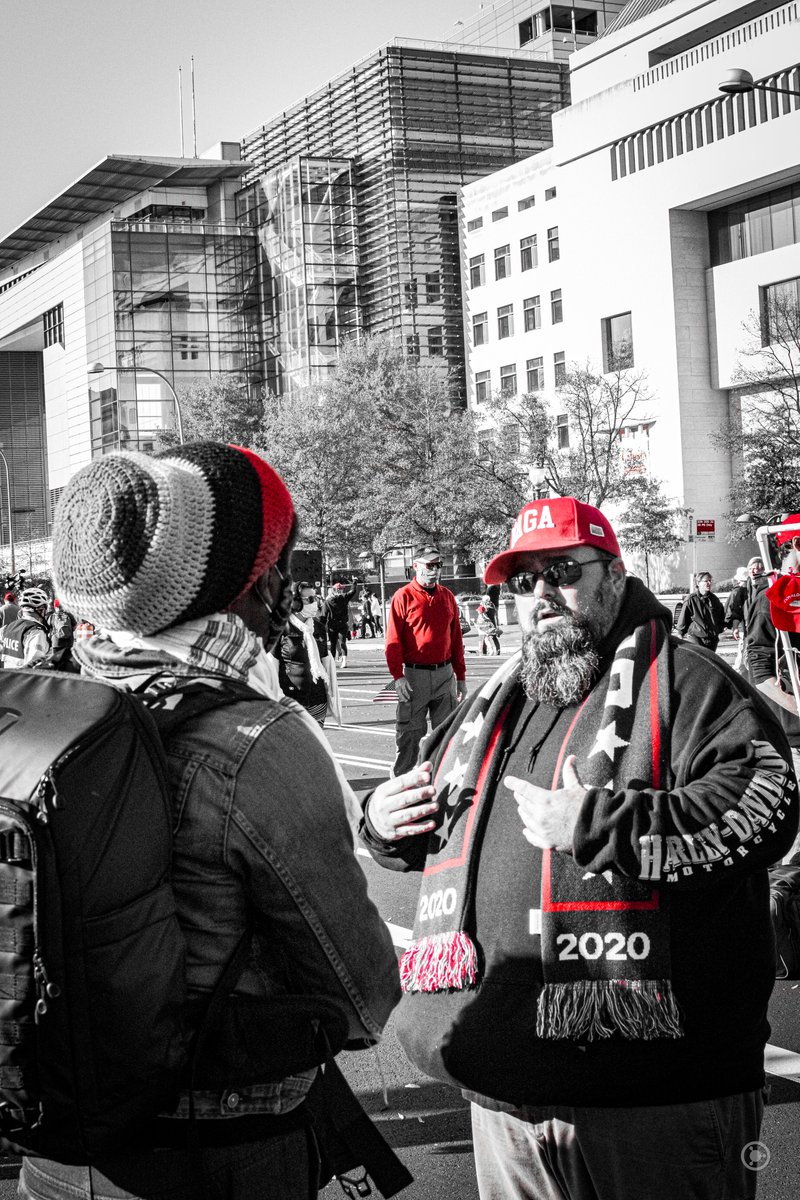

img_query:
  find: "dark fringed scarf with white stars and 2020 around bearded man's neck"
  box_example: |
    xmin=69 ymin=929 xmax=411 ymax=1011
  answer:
xmin=401 ymin=620 xmax=682 ymax=1040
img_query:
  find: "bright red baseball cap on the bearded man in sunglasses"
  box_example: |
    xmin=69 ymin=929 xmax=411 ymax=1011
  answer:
xmin=483 ymin=496 xmax=620 ymax=583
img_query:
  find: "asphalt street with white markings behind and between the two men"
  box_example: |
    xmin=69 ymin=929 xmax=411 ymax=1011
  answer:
xmin=0 ymin=629 xmax=800 ymax=1200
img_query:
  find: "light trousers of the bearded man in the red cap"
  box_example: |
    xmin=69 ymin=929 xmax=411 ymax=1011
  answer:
xmin=473 ymin=1091 xmax=768 ymax=1200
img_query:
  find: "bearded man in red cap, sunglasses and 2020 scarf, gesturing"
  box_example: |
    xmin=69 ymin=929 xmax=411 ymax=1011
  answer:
xmin=361 ymin=498 xmax=798 ymax=1200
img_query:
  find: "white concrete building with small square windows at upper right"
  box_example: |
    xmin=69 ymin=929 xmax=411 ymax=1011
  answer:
xmin=462 ymin=0 xmax=800 ymax=582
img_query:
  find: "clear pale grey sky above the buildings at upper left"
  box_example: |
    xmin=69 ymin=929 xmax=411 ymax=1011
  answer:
xmin=0 ymin=0 xmax=474 ymax=238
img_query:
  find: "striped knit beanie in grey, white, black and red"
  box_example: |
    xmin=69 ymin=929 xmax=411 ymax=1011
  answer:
xmin=53 ymin=442 xmax=294 ymax=636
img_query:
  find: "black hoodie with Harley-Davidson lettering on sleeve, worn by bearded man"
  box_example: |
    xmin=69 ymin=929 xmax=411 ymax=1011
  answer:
xmin=361 ymin=578 xmax=798 ymax=1108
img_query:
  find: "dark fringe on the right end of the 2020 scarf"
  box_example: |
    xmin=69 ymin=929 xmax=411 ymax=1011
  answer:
xmin=536 ymin=979 xmax=684 ymax=1042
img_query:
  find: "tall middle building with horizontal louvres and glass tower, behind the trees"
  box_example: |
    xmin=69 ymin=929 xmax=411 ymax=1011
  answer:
xmin=239 ymin=41 xmax=569 ymax=394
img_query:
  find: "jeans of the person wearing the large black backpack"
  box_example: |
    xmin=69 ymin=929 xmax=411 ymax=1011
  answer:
xmin=17 ymin=1129 xmax=319 ymax=1200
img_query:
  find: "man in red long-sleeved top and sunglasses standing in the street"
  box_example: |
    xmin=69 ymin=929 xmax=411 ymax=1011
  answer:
xmin=385 ymin=546 xmax=467 ymax=776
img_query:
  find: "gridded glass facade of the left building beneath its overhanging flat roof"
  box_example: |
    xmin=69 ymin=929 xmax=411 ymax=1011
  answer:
xmin=83 ymin=211 xmax=265 ymax=455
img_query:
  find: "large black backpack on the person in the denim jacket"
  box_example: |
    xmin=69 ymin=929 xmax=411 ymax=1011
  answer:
xmin=0 ymin=671 xmax=187 ymax=1163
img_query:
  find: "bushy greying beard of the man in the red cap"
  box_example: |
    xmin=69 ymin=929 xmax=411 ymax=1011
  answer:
xmin=519 ymin=612 xmax=600 ymax=708
